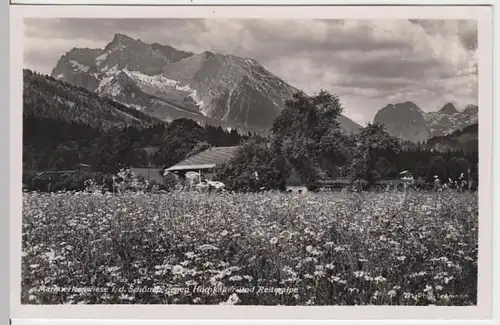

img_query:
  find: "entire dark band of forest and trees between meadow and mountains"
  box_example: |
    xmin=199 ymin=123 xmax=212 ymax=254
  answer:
xmin=23 ymin=71 xmax=477 ymax=190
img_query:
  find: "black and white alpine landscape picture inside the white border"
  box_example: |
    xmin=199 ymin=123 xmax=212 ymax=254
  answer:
xmin=13 ymin=8 xmax=491 ymax=312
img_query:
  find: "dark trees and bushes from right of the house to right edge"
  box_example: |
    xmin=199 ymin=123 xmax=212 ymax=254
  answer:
xmin=216 ymin=91 xmax=478 ymax=191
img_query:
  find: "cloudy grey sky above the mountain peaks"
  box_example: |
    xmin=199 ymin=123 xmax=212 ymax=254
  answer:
xmin=24 ymin=18 xmax=478 ymax=125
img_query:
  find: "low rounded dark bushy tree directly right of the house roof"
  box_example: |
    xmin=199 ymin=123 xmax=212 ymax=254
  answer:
xmin=215 ymin=139 xmax=289 ymax=191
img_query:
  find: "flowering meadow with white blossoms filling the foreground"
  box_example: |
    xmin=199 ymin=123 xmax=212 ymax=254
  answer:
xmin=21 ymin=191 xmax=478 ymax=305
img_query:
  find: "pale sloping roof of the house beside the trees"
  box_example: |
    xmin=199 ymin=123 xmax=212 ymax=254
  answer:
xmin=166 ymin=146 xmax=239 ymax=171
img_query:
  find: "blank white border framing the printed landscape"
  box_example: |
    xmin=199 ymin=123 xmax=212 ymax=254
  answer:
xmin=10 ymin=6 xmax=493 ymax=324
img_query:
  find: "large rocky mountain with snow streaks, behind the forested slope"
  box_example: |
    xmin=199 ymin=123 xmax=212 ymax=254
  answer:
xmin=52 ymin=34 xmax=360 ymax=134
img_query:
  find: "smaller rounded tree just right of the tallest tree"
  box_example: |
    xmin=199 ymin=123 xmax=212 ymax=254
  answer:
xmin=351 ymin=123 xmax=401 ymax=185
